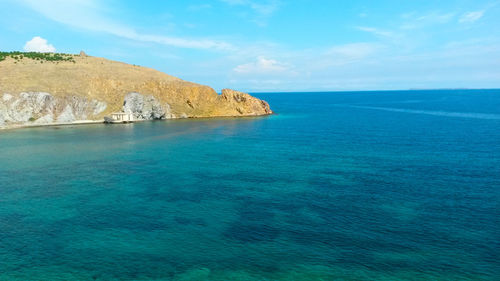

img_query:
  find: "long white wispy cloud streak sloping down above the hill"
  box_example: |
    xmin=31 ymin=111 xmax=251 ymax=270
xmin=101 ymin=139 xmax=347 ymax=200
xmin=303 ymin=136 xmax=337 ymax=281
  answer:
xmin=19 ymin=0 xmax=234 ymax=50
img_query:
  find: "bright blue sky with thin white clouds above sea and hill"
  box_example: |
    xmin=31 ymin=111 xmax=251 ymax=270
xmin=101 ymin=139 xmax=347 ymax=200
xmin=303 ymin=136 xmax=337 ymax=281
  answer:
xmin=0 ymin=0 xmax=500 ymax=92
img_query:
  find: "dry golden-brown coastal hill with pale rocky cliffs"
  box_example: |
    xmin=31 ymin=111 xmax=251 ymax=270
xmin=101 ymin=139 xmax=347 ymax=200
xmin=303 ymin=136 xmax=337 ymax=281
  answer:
xmin=0 ymin=52 xmax=272 ymax=127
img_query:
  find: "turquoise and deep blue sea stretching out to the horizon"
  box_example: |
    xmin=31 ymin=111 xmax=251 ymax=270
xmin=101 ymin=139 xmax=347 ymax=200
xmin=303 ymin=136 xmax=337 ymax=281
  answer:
xmin=0 ymin=90 xmax=500 ymax=280
